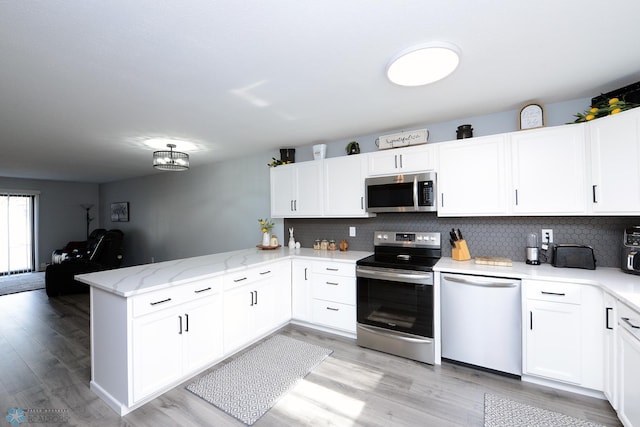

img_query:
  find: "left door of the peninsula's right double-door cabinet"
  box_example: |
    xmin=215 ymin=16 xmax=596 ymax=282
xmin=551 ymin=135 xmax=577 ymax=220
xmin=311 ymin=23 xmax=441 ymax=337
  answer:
xmin=223 ymin=285 xmax=254 ymax=354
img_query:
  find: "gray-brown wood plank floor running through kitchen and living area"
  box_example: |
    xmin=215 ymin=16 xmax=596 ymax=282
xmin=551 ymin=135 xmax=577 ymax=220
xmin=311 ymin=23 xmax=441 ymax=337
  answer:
xmin=0 ymin=290 xmax=620 ymax=427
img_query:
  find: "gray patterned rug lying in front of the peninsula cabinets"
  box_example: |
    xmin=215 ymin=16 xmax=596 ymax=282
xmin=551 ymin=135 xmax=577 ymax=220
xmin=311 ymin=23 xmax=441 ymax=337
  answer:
xmin=187 ymin=335 xmax=333 ymax=425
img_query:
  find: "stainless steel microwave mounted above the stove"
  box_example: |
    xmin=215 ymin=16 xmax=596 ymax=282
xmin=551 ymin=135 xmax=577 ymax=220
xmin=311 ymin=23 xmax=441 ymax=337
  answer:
xmin=365 ymin=171 xmax=438 ymax=212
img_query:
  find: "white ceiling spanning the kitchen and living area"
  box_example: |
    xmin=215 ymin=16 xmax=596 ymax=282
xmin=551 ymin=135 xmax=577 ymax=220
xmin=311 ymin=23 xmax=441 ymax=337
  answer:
xmin=0 ymin=0 xmax=640 ymax=183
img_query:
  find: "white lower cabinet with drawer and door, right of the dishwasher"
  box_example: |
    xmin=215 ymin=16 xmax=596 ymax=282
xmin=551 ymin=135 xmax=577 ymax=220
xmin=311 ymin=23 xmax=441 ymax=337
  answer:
xmin=523 ymin=280 xmax=604 ymax=391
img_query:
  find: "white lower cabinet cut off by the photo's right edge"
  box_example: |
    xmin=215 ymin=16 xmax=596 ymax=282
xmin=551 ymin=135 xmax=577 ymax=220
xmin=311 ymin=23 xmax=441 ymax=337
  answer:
xmin=616 ymin=303 xmax=640 ymax=427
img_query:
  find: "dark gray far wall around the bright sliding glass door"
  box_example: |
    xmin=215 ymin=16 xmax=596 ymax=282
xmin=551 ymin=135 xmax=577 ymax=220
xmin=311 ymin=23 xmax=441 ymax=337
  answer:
xmin=0 ymin=177 xmax=100 ymax=268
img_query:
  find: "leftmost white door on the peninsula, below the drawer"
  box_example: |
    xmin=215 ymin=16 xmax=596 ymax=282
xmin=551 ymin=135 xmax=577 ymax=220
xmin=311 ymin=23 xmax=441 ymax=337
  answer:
xmin=131 ymin=309 xmax=185 ymax=402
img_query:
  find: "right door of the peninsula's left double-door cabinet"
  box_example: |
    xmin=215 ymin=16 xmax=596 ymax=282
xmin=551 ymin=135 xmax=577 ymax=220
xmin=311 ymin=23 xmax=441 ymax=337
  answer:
xmin=182 ymin=294 xmax=222 ymax=373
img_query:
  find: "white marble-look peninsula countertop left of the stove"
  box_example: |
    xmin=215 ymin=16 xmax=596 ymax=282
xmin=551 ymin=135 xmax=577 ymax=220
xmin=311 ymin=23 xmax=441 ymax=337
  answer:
xmin=75 ymin=248 xmax=371 ymax=297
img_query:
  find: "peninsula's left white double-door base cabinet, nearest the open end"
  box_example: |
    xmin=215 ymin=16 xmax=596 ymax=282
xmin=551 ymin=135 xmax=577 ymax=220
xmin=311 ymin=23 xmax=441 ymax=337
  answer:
xmin=131 ymin=279 xmax=222 ymax=402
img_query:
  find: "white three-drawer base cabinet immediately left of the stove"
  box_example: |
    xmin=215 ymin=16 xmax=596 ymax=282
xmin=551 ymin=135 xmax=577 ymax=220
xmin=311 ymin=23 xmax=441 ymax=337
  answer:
xmin=311 ymin=261 xmax=356 ymax=334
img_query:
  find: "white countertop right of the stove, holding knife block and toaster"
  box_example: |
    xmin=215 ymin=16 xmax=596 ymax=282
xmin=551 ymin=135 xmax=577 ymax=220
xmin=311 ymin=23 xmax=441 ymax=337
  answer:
xmin=434 ymin=258 xmax=640 ymax=312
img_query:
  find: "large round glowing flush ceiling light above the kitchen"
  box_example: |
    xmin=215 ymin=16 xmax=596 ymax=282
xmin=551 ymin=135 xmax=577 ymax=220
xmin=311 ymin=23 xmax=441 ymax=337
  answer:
xmin=387 ymin=42 xmax=460 ymax=86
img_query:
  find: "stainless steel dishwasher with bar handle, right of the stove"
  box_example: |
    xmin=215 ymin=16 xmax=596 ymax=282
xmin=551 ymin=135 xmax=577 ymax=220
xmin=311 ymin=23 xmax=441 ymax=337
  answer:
xmin=440 ymin=273 xmax=522 ymax=376
